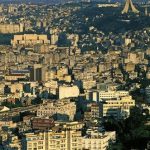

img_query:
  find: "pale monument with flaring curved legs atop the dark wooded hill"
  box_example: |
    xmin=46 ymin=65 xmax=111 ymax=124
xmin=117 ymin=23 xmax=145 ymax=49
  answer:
xmin=121 ymin=0 xmax=139 ymax=14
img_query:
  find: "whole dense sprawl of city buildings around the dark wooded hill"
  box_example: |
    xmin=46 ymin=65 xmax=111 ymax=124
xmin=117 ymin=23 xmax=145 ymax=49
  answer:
xmin=0 ymin=4 xmax=150 ymax=150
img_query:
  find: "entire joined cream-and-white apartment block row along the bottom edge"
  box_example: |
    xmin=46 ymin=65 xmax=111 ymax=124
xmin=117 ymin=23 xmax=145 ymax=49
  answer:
xmin=22 ymin=126 xmax=116 ymax=150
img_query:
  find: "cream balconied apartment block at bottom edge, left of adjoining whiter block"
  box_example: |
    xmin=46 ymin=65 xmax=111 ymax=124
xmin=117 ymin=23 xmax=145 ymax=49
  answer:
xmin=22 ymin=130 xmax=82 ymax=150
